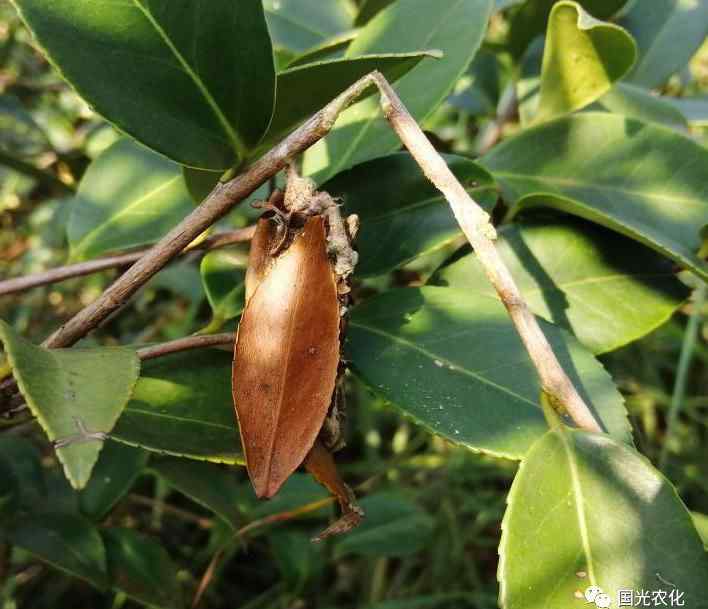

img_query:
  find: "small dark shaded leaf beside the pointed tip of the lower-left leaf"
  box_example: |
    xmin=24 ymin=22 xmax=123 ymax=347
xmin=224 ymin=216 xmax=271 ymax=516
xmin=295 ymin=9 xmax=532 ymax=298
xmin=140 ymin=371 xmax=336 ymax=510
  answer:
xmin=79 ymin=442 xmax=148 ymax=521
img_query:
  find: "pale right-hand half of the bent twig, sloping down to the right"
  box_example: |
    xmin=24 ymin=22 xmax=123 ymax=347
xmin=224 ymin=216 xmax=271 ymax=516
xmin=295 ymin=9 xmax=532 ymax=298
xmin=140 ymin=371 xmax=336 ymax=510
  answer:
xmin=373 ymin=72 xmax=602 ymax=431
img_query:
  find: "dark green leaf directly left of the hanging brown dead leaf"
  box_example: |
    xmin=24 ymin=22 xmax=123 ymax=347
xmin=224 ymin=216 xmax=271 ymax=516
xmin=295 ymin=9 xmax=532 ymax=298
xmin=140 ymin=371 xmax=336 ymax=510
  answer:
xmin=111 ymin=349 xmax=242 ymax=463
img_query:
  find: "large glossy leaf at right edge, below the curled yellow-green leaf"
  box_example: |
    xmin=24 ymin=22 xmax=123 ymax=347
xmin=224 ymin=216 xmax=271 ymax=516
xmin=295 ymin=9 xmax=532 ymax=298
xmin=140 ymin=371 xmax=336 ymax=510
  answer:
xmin=480 ymin=112 xmax=708 ymax=278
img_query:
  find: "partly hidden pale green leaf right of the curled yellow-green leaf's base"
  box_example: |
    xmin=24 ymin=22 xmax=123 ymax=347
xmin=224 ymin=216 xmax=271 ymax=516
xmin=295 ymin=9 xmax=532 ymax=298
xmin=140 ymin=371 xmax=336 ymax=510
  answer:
xmin=596 ymin=82 xmax=688 ymax=132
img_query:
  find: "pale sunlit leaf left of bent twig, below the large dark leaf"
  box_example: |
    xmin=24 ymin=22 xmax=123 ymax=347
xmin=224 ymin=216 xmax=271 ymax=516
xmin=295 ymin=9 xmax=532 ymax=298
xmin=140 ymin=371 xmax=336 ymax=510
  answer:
xmin=67 ymin=139 xmax=194 ymax=261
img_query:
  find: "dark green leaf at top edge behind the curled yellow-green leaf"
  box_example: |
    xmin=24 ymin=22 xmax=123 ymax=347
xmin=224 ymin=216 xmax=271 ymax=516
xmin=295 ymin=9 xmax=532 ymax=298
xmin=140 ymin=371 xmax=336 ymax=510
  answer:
xmin=509 ymin=0 xmax=627 ymax=57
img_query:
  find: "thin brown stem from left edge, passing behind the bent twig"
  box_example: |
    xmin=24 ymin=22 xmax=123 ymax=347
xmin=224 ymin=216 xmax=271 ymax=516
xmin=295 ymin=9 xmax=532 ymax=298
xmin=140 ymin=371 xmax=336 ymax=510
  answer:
xmin=0 ymin=226 xmax=255 ymax=296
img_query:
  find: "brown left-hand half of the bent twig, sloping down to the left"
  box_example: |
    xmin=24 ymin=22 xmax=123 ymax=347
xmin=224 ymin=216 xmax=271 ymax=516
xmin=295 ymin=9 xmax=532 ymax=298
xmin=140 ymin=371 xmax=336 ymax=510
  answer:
xmin=43 ymin=75 xmax=373 ymax=348
